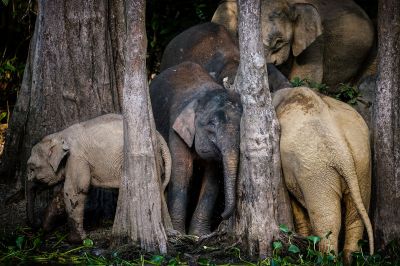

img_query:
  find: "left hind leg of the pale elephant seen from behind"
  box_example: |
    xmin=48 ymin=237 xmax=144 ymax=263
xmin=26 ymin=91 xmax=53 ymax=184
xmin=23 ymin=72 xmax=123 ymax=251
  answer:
xmin=300 ymin=178 xmax=341 ymax=254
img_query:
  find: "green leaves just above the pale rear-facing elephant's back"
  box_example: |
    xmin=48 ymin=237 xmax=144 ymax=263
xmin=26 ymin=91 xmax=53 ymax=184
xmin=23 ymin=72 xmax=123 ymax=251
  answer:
xmin=290 ymin=77 xmax=361 ymax=105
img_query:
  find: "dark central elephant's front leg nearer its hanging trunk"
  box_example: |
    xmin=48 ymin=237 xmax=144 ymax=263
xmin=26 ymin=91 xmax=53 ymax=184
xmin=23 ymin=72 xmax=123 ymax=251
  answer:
xmin=189 ymin=163 xmax=219 ymax=236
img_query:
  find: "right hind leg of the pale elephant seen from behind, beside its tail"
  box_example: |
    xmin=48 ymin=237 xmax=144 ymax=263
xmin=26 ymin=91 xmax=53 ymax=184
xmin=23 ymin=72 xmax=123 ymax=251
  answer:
xmin=343 ymin=193 xmax=364 ymax=263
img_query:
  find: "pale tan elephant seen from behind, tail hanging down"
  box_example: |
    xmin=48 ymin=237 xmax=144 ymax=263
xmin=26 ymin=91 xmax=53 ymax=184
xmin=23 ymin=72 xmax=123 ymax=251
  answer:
xmin=273 ymin=87 xmax=374 ymax=258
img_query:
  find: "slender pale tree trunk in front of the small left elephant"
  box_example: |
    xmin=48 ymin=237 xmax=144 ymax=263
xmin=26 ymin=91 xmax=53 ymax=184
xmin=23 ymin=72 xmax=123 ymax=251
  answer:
xmin=112 ymin=0 xmax=167 ymax=253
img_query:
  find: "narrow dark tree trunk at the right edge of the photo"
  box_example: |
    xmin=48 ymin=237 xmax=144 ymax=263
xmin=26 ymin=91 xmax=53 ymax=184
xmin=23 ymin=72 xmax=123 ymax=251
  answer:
xmin=374 ymin=0 xmax=400 ymax=248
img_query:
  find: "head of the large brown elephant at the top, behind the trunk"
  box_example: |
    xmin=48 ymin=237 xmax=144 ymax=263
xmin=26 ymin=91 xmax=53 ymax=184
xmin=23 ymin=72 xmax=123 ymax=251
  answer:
xmin=212 ymin=0 xmax=322 ymax=65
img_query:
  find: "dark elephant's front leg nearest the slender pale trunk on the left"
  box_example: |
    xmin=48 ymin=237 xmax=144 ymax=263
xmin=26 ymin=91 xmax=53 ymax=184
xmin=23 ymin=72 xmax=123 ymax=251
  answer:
xmin=168 ymin=133 xmax=193 ymax=234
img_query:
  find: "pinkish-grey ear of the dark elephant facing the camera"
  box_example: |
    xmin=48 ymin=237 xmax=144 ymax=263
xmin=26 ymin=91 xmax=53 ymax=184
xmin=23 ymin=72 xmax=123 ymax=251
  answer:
xmin=172 ymin=100 xmax=197 ymax=147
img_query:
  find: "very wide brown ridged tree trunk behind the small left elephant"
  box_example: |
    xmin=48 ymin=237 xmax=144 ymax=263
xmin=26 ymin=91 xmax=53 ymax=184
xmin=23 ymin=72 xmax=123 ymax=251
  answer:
xmin=1 ymin=0 xmax=123 ymax=227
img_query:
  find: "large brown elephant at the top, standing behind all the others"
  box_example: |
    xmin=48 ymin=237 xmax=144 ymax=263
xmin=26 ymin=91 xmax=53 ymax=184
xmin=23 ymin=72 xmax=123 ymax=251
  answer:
xmin=212 ymin=0 xmax=374 ymax=91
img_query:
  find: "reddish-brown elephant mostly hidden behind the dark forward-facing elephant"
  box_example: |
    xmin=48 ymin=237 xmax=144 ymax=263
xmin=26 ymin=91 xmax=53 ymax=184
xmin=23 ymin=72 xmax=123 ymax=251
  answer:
xmin=160 ymin=22 xmax=290 ymax=91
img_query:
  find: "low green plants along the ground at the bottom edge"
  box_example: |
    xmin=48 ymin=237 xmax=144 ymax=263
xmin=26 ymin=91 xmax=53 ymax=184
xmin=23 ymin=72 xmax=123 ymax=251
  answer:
xmin=0 ymin=225 xmax=400 ymax=266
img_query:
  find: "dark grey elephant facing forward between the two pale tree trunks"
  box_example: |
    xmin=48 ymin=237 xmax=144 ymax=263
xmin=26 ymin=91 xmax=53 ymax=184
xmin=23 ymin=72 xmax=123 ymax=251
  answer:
xmin=150 ymin=62 xmax=242 ymax=235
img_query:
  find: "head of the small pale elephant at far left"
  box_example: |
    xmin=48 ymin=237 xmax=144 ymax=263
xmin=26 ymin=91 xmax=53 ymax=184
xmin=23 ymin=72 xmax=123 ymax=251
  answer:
xmin=27 ymin=135 xmax=69 ymax=185
